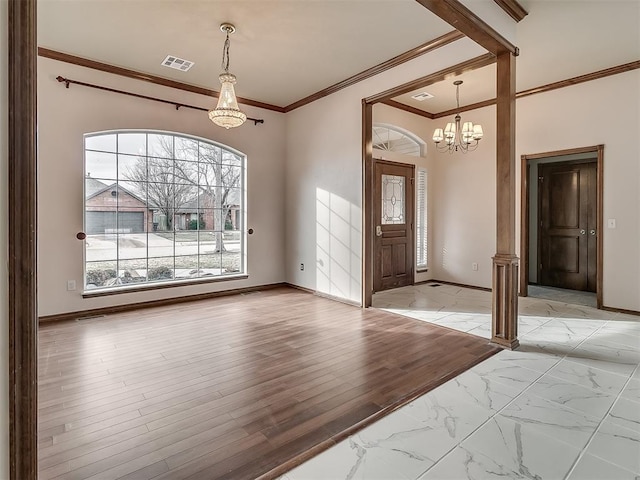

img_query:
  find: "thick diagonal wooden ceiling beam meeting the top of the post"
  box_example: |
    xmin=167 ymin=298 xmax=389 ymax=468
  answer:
xmin=416 ymin=0 xmax=518 ymax=55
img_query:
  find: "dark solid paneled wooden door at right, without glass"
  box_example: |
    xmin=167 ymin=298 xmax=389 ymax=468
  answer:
xmin=538 ymin=162 xmax=600 ymax=292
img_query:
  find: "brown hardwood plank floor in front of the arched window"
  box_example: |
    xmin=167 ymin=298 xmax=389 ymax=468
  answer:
xmin=38 ymin=288 xmax=498 ymax=480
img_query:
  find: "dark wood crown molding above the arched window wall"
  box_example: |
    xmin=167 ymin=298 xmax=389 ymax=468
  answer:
xmin=38 ymin=47 xmax=284 ymax=113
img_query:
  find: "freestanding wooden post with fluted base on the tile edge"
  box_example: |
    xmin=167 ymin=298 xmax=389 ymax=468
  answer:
xmin=491 ymin=52 xmax=519 ymax=349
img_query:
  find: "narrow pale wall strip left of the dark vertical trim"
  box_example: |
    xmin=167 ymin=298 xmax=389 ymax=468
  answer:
xmin=0 ymin=2 xmax=9 ymax=478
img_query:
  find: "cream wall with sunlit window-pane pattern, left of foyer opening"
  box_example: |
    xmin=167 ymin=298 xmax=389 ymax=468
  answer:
xmin=285 ymin=39 xmax=483 ymax=302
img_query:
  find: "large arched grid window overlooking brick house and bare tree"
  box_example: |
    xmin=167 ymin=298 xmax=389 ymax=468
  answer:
xmin=84 ymin=131 xmax=246 ymax=290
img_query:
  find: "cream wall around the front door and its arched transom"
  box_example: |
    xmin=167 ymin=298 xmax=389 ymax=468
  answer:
xmin=373 ymin=103 xmax=435 ymax=282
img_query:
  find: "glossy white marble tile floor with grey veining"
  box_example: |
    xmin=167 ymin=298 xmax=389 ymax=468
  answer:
xmin=281 ymin=284 xmax=640 ymax=480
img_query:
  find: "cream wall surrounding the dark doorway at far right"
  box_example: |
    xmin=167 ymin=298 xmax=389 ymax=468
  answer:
xmin=516 ymin=70 xmax=640 ymax=311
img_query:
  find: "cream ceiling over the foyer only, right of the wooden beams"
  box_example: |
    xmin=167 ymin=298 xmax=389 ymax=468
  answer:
xmin=394 ymin=0 xmax=640 ymax=113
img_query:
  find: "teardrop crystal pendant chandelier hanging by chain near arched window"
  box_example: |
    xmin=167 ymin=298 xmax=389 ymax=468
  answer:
xmin=209 ymin=23 xmax=247 ymax=130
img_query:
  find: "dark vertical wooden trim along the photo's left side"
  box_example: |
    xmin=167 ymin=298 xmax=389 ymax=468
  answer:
xmin=8 ymin=0 xmax=38 ymax=480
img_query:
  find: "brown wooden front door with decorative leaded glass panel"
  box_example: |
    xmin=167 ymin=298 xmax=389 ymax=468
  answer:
xmin=373 ymin=160 xmax=415 ymax=292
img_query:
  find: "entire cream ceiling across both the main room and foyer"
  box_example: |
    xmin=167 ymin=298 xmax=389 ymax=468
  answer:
xmin=38 ymin=0 xmax=640 ymax=113
